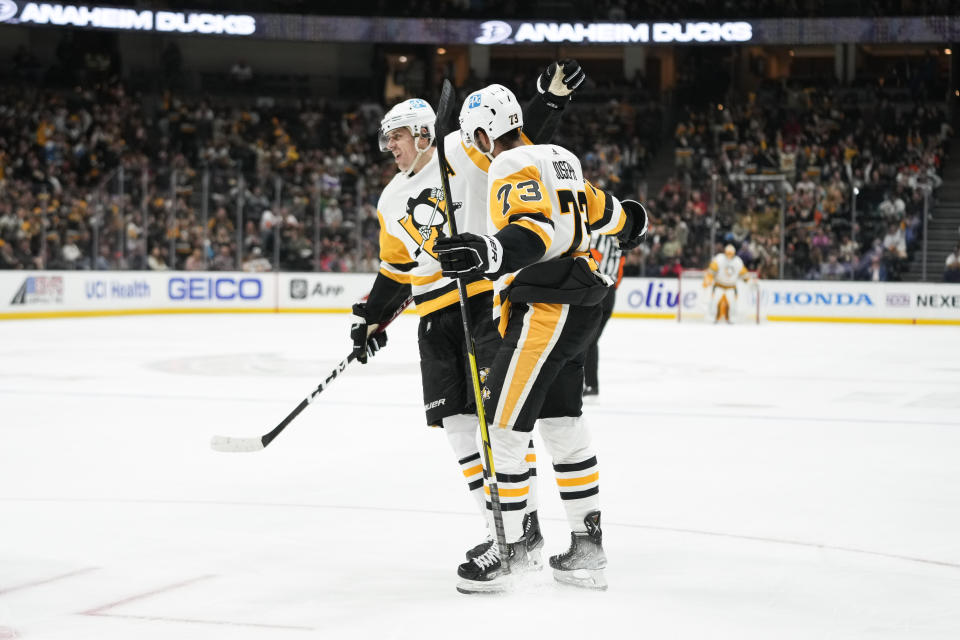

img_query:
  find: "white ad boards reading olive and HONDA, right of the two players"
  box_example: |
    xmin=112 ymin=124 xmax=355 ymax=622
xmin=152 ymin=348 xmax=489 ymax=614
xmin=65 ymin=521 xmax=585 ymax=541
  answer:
xmin=614 ymin=278 xmax=960 ymax=320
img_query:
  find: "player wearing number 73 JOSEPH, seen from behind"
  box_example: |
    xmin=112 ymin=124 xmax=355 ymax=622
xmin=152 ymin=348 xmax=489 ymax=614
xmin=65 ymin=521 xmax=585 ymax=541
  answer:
xmin=435 ymin=85 xmax=646 ymax=593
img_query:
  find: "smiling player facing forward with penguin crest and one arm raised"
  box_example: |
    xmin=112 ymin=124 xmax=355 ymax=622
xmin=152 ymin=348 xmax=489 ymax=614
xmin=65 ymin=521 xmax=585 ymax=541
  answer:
xmin=350 ymin=60 xmax=585 ymax=559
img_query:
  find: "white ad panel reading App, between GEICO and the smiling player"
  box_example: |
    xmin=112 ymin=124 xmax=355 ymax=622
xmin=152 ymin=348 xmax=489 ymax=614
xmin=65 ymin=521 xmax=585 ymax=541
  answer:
xmin=278 ymin=273 xmax=377 ymax=310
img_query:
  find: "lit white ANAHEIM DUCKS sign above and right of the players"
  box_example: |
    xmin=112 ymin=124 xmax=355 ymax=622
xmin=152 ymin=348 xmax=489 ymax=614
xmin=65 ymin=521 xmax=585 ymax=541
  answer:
xmin=473 ymin=20 xmax=753 ymax=44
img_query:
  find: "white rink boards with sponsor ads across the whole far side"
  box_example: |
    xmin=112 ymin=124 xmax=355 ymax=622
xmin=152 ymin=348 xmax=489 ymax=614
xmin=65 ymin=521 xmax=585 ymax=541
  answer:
xmin=0 ymin=271 xmax=960 ymax=324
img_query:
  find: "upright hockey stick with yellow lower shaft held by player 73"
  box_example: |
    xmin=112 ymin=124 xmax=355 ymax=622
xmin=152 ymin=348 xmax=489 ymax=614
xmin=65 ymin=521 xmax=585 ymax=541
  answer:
xmin=436 ymin=79 xmax=510 ymax=573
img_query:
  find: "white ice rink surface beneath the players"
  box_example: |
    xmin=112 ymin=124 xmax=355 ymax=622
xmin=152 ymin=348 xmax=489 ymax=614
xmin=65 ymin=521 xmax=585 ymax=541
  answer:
xmin=0 ymin=315 xmax=960 ymax=640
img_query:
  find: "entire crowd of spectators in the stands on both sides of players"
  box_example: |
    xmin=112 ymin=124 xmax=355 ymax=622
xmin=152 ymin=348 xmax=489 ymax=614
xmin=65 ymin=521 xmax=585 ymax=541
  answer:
xmin=0 ymin=48 xmax=953 ymax=280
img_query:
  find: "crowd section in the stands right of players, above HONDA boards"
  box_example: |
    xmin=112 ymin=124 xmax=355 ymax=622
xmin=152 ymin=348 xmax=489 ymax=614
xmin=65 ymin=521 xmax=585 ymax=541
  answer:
xmin=629 ymin=81 xmax=953 ymax=280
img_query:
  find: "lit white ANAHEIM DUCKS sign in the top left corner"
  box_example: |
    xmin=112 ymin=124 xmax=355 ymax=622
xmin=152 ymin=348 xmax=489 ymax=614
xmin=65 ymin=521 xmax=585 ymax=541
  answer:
xmin=0 ymin=0 xmax=257 ymax=36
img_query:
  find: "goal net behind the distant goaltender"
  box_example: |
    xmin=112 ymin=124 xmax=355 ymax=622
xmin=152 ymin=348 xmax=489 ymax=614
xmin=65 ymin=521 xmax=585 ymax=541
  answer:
xmin=677 ymin=269 xmax=760 ymax=324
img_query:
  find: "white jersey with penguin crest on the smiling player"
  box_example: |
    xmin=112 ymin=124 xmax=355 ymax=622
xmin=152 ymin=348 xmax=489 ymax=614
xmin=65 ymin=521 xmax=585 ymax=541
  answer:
xmin=377 ymin=131 xmax=492 ymax=316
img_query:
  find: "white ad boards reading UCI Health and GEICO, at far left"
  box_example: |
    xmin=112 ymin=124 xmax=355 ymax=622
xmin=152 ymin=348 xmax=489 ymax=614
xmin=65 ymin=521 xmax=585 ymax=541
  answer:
xmin=0 ymin=271 xmax=276 ymax=315
